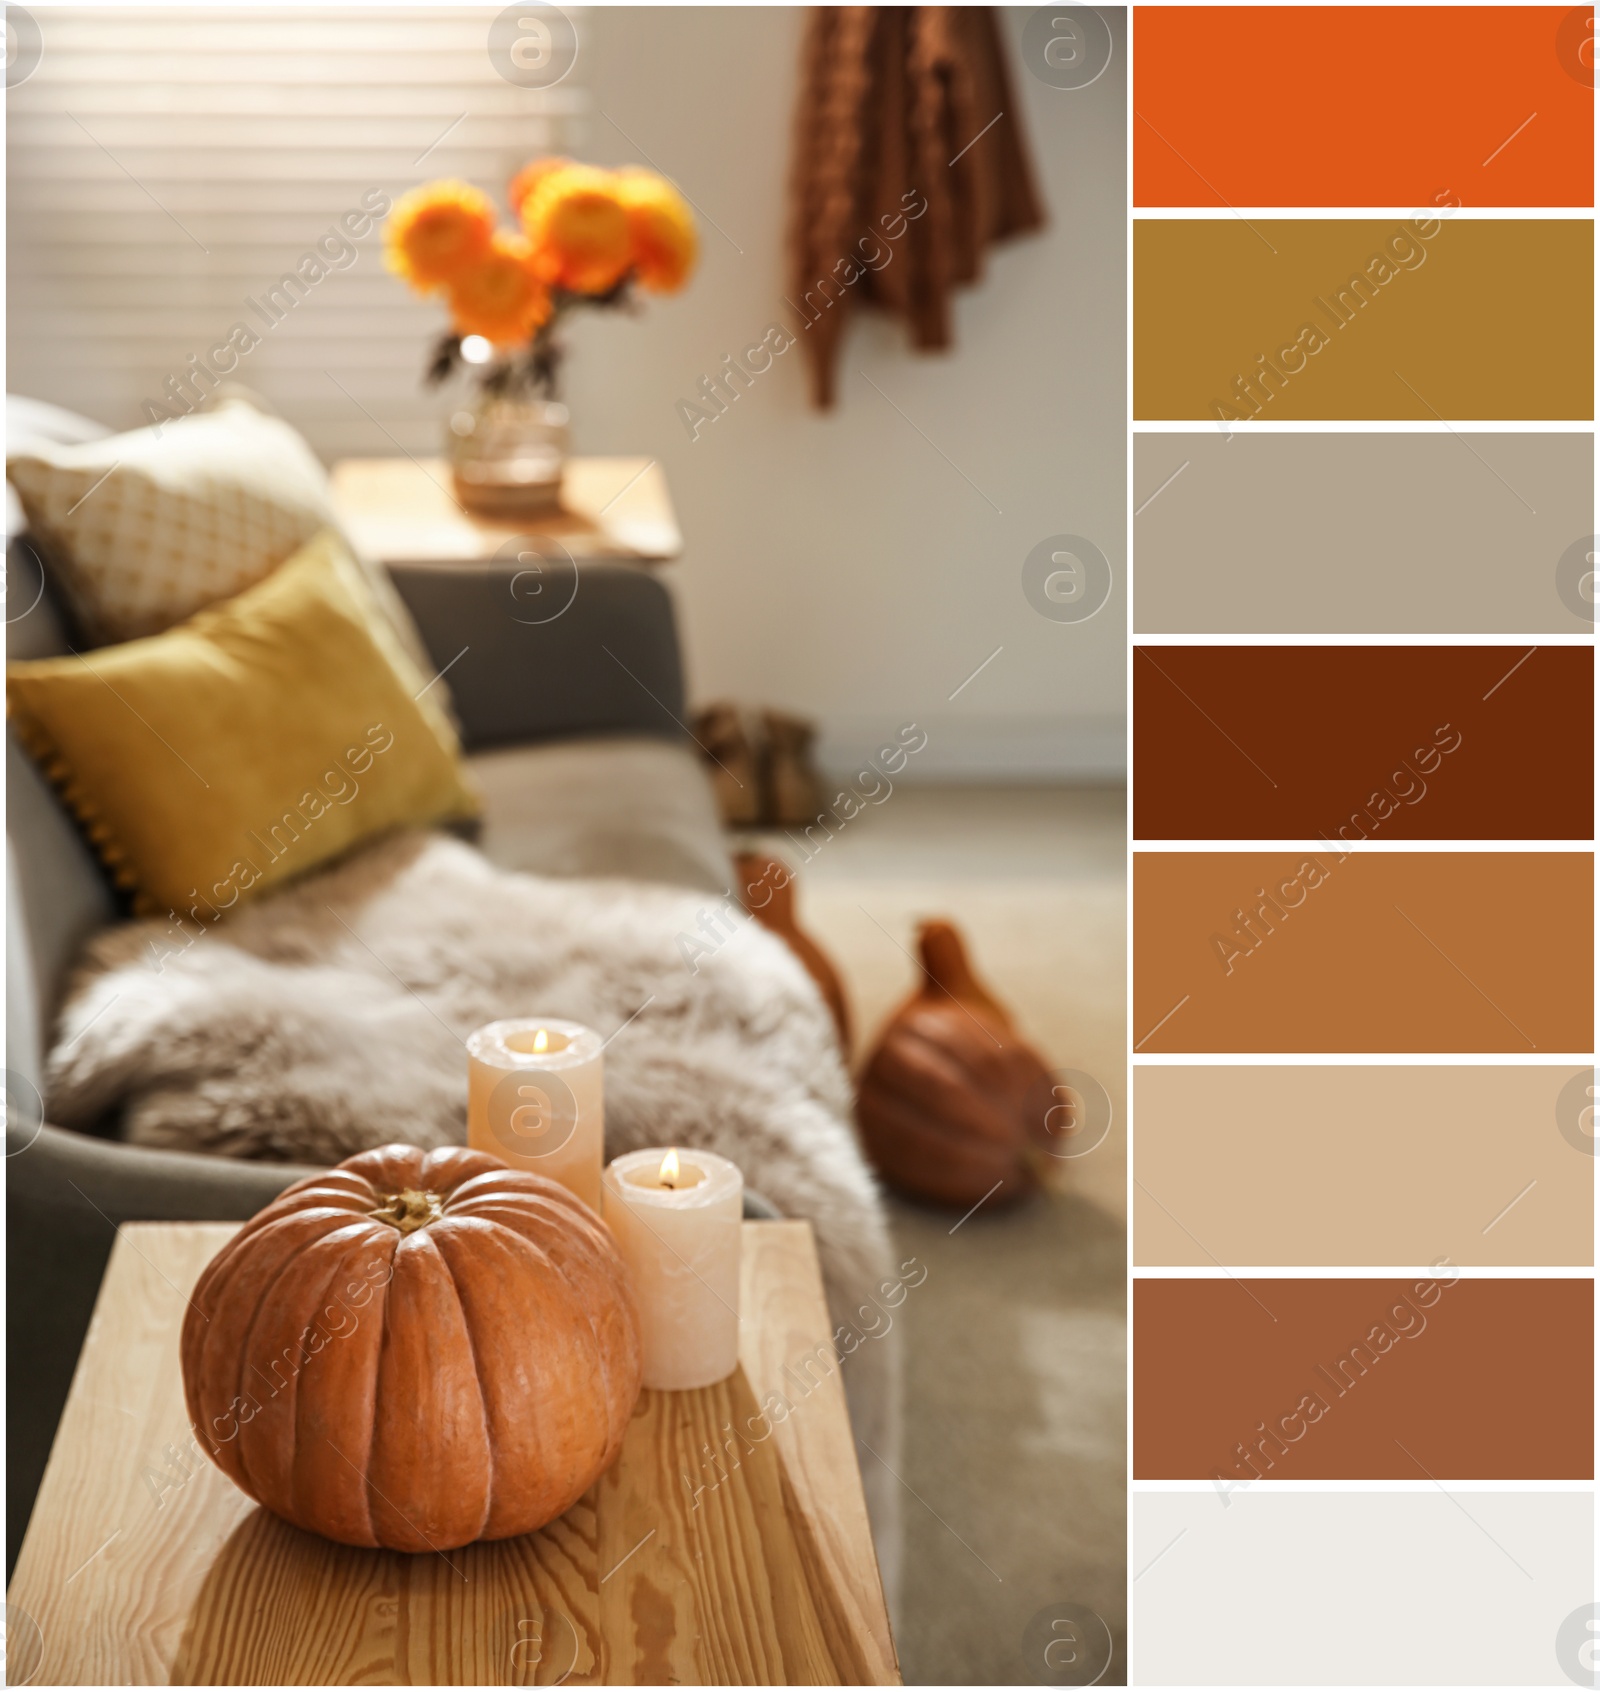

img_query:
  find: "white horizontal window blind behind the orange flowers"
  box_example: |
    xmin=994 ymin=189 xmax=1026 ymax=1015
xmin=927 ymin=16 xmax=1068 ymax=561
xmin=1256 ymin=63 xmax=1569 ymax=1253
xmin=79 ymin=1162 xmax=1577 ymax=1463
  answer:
xmin=7 ymin=5 xmax=585 ymax=459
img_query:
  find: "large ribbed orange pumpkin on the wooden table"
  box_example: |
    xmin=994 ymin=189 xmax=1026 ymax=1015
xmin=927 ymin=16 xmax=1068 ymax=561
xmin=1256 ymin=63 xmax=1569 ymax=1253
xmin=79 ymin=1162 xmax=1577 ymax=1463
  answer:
xmin=183 ymin=1145 xmax=639 ymax=1552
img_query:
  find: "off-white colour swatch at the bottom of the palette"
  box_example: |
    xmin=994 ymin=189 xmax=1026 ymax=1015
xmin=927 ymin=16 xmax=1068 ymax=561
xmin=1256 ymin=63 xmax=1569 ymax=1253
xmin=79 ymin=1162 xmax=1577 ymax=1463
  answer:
xmin=1128 ymin=1488 xmax=1595 ymax=1685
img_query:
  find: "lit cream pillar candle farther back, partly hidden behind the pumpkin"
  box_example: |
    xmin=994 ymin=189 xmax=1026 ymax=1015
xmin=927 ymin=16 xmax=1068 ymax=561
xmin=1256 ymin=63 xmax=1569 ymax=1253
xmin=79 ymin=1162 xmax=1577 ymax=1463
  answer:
xmin=467 ymin=1017 xmax=605 ymax=1211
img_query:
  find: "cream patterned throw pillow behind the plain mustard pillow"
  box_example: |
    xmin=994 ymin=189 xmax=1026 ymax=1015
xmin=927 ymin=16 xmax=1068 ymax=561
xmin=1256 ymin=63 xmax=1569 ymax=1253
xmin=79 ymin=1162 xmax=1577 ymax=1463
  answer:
xmin=5 ymin=399 xmax=333 ymax=645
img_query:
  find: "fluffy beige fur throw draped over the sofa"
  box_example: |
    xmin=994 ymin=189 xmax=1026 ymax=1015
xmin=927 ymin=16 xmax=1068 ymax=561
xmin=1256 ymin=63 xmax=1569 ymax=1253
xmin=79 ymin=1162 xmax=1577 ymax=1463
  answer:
xmin=46 ymin=832 xmax=898 ymax=1577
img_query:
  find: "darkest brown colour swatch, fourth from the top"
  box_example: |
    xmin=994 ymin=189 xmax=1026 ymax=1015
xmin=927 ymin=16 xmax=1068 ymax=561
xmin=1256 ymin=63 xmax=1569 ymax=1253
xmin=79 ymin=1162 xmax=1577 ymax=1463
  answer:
xmin=1133 ymin=645 xmax=1595 ymax=841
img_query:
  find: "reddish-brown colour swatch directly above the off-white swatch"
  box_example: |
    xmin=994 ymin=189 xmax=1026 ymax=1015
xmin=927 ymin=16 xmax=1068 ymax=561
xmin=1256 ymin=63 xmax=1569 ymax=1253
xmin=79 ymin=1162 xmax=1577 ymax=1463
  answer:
xmin=1133 ymin=1279 xmax=1595 ymax=1484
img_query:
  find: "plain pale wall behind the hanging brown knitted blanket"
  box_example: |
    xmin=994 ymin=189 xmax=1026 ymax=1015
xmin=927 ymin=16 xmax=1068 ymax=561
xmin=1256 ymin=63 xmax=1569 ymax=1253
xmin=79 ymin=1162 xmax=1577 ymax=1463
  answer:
xmin=568 ymin=7 xmax=1126 ymax=778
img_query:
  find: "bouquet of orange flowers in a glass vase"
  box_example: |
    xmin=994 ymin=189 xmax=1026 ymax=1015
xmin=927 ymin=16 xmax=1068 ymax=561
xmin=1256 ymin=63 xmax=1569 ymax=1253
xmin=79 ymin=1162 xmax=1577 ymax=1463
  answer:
xmin=384 ymin=157 xmax=699 ymax=514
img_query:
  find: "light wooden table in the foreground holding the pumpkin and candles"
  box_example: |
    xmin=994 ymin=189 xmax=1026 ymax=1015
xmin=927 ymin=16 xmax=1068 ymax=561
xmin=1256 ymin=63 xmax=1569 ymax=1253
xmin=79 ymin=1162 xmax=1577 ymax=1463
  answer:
xmin=7 ymin=1222 xmax=898 ymax=1685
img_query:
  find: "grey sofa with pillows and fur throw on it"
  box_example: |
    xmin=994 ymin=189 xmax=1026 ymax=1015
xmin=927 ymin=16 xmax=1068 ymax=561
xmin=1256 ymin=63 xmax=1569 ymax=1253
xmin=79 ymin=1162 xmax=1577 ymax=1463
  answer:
xmin=5 ymin=403 xmax=732 ymax=1568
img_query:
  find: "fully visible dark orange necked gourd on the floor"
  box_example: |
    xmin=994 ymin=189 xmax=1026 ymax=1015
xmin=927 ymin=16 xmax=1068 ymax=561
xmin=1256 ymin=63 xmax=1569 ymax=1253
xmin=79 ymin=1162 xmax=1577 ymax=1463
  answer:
xmin=856 ymin=920 xmax=1055 ymax=1208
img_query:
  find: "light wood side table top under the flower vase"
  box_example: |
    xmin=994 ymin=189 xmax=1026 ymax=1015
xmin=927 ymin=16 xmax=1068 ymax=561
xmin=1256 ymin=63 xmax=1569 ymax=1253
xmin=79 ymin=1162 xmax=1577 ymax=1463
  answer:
xmin=332 ymin=459 xmax=683 ymax=565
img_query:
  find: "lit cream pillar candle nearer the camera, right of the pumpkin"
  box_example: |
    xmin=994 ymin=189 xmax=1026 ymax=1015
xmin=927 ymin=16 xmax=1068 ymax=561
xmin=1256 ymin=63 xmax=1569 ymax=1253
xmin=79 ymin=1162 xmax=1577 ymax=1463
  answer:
xmin=604 ymin=1145 xmax=744 ymax=1391
